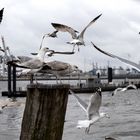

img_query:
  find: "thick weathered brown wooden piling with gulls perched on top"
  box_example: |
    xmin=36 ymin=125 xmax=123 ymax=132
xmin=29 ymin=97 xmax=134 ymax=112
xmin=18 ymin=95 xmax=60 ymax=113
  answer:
xmin=20 ymin=84 xmax=70 ymax=140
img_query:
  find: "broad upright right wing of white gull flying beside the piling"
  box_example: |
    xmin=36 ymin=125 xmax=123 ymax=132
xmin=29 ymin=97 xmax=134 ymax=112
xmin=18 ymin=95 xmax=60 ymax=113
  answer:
xmin=87 ymin=91 xmax=102 ymax=120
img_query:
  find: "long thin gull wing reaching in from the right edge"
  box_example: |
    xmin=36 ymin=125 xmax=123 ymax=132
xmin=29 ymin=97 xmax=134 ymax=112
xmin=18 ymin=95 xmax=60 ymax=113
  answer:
xmin=91 ymin=42 xmax=140 ymax=72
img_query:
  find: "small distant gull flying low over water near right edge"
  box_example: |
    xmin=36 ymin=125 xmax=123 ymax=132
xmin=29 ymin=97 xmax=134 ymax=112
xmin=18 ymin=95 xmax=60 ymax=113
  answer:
xmin=112 ymin=84 xmax=137 ymax=96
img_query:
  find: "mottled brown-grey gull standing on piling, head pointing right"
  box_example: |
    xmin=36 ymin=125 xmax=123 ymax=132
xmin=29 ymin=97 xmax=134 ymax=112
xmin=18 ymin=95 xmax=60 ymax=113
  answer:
xmin=39 ymin=61 xmax=80 ymax=81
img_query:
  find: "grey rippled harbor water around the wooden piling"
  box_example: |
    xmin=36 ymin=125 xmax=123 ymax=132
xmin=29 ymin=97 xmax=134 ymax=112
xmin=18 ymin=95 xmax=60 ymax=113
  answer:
xmin=0 ymin=81 xmax=140 ymax=140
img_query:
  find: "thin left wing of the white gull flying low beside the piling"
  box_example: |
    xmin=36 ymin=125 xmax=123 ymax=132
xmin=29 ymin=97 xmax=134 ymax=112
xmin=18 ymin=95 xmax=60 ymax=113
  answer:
xmin=69 ymin=90 xmax=88 ymax=112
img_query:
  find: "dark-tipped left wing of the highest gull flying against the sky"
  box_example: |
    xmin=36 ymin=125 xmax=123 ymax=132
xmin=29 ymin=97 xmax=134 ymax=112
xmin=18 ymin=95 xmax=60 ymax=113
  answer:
xmin=51 ymin=23 xmax=78 ymax=39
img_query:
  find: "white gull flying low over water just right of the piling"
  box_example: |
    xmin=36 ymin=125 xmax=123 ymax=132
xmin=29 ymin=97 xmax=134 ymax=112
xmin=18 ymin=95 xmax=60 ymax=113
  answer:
xmin=70 ymin=88 xmax=109 ymax=133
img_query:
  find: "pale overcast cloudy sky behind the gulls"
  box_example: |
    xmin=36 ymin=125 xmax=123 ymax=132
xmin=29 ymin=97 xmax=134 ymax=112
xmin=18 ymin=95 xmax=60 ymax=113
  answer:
xmin=0 ymin=0 xmax=140 ymax=71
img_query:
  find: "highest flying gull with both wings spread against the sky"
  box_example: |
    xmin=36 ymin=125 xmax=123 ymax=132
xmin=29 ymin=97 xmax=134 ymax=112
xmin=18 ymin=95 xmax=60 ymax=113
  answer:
xmin=50 ymin=14 xmax=102 ymax=51
